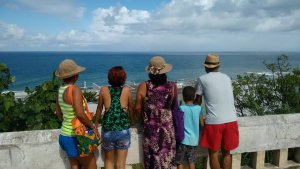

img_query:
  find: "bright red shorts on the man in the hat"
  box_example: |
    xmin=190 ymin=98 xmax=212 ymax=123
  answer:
xmin=199 ymin=121 xmax=239 ymax=151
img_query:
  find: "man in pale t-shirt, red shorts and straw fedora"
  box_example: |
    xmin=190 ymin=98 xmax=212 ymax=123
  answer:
xmin=195 ymin=54 xmax=239 ymax=169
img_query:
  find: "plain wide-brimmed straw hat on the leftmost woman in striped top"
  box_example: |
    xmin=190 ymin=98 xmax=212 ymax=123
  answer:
xmin=55 ymin=59 xmax=85 ymax=79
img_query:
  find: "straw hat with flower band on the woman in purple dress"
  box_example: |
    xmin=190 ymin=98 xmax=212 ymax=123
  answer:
xmin=146 ymin=56 xmax=173 ymax=75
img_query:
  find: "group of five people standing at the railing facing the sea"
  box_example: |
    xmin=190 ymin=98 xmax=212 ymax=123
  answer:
xmin=56 ymin=54 xmax=239 ymax=169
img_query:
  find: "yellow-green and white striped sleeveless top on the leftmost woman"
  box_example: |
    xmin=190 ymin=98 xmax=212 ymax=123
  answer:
xmin=58 ymin=85 xmax=86 ymax=136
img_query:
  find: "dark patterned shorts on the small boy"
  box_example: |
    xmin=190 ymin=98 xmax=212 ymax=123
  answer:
xmin=175 ymin=144 xmax=200 ymax=164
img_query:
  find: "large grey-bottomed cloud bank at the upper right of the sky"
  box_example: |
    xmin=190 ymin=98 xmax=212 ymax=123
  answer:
xmin=151 ymin=0 xmax=300 ymax=33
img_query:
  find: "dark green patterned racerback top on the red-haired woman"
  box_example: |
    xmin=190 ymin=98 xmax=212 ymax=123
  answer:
xmin=102 ymin=86 xmax=130 ymax=131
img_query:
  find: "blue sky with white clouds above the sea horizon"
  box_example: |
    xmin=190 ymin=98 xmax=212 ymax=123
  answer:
xmin=0 ymin=0 xmax=300 ymax=52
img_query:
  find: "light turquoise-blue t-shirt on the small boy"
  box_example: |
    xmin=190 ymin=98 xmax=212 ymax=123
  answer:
xmin=180 ymin=105 xmax=202 ymax=146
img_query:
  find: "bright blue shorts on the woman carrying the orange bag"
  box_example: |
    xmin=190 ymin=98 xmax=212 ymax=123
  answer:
xmin=59 ymin=134 xmax=79 ymax=158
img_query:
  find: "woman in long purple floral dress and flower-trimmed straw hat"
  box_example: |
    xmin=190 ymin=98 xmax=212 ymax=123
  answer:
xmin=135 ymin=56 xmax=177 ymax=169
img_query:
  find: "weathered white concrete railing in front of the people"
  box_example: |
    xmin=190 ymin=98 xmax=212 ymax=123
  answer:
xmin=0 ymin=111 xmax=300 ymax=169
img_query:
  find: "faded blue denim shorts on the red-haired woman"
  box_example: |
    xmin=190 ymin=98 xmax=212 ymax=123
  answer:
xmin=101 ymin=129 xmax=131 ymax=151
